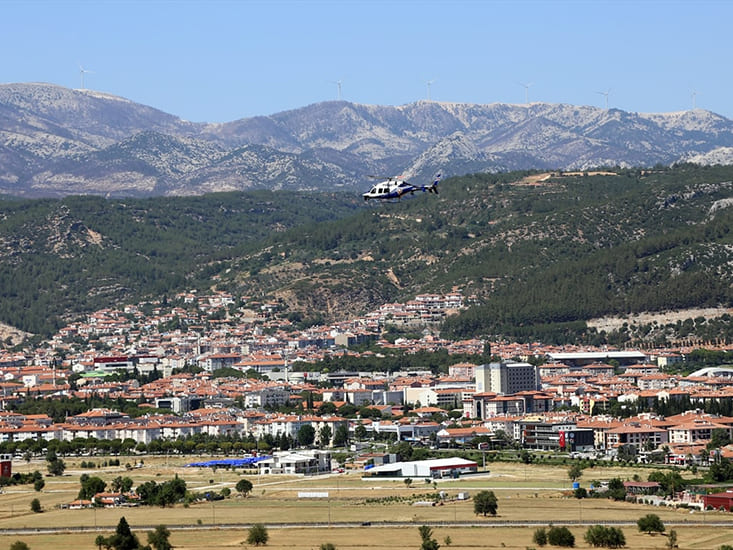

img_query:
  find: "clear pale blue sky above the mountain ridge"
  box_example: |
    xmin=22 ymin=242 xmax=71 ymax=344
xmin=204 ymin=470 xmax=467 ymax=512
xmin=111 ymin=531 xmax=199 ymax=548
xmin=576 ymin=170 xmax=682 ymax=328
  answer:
xmin=0 ymin=0 xmax=733 ymax=122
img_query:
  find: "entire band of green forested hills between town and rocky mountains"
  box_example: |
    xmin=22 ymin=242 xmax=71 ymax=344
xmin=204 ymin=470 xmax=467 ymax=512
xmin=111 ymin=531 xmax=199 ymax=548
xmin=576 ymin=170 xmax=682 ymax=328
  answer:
xmin=0 ymin=165 xmax=733 ymax=342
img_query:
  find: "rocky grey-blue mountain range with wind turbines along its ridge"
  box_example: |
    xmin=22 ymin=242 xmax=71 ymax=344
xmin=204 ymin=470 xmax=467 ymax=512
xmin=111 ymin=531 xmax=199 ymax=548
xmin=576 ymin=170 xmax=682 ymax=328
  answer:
xmin=0 ymin=84 xmax=733 ymax=198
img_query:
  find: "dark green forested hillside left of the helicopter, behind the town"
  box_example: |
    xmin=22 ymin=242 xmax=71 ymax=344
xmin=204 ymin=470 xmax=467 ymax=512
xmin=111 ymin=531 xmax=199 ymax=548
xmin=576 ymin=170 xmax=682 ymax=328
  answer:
xmin=0 ymin=191 xmax=360 ymax=335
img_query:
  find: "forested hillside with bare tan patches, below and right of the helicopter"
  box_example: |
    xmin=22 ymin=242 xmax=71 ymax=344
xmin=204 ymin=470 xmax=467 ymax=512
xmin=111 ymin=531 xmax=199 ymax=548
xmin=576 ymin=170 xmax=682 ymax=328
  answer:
xmin=222 ymin=166 xmax=733 ymax=340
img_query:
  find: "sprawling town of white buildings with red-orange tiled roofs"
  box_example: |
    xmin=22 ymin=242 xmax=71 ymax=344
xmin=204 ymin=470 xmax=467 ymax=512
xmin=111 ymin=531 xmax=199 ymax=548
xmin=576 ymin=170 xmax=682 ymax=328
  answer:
xmin=0 ymin=289 xmax=733 ymax=471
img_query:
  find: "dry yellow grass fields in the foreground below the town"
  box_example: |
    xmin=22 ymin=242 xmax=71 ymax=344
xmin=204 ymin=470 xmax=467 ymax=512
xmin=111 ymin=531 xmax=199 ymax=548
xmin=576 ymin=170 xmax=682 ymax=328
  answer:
xmin=0 ymin=457 xmax=733 ymax=550
